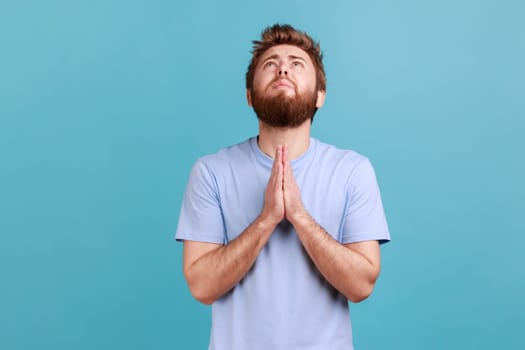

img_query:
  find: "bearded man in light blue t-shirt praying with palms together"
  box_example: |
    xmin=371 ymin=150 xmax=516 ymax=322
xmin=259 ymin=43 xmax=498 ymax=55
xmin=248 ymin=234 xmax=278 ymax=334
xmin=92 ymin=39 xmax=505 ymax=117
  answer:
xmin=175 ymin=24 xmax=390 ymax=350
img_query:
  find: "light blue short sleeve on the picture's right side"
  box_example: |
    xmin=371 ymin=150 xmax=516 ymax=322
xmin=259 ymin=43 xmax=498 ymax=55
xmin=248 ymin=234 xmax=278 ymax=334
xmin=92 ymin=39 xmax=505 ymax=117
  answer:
xmin=342 ymin=158 xmax=390 ymax=244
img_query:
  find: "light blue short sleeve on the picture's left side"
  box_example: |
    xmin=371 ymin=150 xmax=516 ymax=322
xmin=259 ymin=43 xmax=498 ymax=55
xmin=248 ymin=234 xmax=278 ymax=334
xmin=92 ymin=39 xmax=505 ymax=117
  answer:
xmin=175 ymin=159 xmax=225 ymax=244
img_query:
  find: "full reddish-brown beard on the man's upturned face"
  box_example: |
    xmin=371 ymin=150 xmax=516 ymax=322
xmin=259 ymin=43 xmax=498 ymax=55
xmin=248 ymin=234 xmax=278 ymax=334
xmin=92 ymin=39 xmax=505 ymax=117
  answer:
xmin=251 ymin=86 xmax=317 ymax=128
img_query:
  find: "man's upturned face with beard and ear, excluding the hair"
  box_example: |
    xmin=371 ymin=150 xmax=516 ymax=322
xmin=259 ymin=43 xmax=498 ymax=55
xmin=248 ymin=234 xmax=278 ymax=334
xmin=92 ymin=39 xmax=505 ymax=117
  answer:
xmin=248 ymin=45 xmax=324 ymax=127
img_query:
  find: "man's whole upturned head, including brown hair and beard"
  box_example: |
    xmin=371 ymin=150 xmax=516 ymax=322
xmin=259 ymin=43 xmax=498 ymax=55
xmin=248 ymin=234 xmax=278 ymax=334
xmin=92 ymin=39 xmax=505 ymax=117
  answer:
xmin=246 ymin=24 xmax=326 ymax=127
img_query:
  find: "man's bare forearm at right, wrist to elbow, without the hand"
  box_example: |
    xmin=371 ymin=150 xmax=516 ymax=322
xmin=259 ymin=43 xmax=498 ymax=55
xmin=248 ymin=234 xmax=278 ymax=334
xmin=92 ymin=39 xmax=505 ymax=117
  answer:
xmin=292 ymin=215 xmax=379 ymax=302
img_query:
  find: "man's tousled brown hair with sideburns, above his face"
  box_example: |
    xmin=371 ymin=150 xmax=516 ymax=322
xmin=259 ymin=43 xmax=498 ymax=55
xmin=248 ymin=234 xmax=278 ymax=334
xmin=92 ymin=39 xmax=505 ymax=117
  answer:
xmin=246 ymin=24 xmax=326 ymax=91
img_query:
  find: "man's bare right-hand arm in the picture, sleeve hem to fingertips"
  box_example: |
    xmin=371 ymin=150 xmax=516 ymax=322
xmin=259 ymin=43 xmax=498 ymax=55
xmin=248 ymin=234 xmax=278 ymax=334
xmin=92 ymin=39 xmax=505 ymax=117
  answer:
xmin=283 ymin=146 xmax=381 ymax=302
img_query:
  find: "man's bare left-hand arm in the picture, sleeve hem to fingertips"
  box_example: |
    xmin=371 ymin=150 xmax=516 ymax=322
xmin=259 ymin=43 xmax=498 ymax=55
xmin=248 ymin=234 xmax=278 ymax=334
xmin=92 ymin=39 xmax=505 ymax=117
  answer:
xmin=183 ymin=148 xmax=284 ymax=304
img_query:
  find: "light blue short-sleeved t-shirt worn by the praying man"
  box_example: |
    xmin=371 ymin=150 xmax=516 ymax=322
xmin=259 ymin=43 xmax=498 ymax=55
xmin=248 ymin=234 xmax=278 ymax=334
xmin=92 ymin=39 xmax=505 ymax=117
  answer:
xmin=175 ymin=137 xmax=390 ymax=350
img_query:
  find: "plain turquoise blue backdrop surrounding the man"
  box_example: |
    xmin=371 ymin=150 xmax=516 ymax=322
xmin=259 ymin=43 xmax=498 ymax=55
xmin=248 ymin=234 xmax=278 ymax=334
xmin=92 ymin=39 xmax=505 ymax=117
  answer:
xmin=0 ymin=0 xmax=525 ymax=349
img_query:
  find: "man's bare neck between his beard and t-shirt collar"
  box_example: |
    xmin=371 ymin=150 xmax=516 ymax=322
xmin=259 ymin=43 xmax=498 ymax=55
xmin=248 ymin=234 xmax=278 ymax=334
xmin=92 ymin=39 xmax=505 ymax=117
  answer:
xmin=258 ymin=120 xmax=311 ymax=160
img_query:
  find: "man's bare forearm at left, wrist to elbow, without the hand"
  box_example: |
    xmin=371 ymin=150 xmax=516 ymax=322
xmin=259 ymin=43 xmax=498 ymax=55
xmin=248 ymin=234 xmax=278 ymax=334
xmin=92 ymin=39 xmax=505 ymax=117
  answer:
xmin=185 ymin=216 xmax=275 ymax=304
